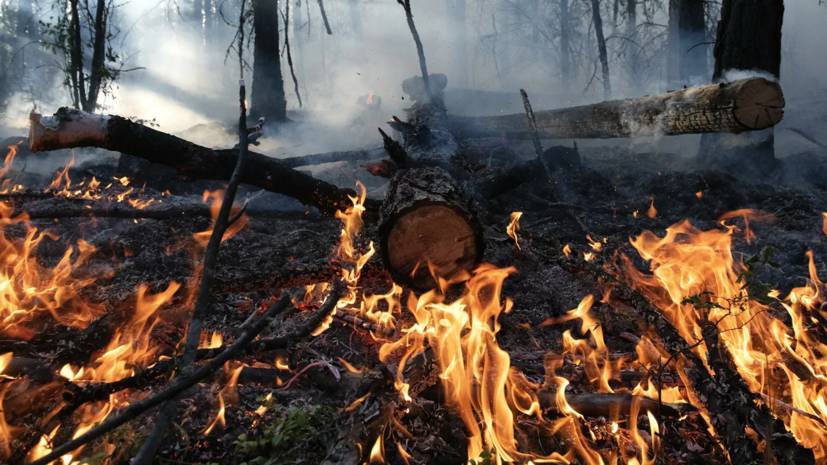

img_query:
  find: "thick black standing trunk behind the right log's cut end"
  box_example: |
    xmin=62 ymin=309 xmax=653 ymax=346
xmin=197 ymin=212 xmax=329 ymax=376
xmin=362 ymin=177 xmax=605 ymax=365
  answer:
xmin=699 ymin=0 xmax=784 ymax=175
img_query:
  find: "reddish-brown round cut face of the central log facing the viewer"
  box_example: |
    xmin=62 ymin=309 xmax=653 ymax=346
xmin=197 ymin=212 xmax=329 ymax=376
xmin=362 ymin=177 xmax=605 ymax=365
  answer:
xmin=386 ymin=204 xmax=480 ymax=288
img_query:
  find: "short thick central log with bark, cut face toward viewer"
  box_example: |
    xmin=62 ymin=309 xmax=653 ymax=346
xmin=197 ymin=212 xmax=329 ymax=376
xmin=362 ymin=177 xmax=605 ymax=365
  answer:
xmin=379 ymin=168 xmax=484 ymax=289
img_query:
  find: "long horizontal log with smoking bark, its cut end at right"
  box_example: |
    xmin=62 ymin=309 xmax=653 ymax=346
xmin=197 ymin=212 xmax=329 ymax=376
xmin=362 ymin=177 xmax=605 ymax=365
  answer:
xmin=449 ymin=78 xmax=785 ymax=139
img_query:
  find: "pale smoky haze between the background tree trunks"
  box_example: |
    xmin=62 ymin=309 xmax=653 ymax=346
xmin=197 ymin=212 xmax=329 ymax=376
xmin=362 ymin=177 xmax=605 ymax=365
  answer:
xmin=5 ymin=0 xmax=827 ymax=154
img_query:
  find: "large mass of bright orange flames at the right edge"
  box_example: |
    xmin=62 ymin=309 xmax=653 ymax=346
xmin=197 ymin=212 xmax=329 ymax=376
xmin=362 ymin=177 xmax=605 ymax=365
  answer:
xmin=624 ymin=216 xmax=827 ymax=462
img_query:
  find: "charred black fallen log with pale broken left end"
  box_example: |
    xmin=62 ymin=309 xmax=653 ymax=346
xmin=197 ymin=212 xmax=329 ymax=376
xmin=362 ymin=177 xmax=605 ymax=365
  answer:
xmin=29 ymin=108 xmax=352 ymax=214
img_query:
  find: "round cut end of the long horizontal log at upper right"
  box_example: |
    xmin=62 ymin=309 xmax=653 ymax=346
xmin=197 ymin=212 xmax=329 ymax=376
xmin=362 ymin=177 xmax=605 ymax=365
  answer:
xmin=734 ymin=78 xmax=785 ymax=130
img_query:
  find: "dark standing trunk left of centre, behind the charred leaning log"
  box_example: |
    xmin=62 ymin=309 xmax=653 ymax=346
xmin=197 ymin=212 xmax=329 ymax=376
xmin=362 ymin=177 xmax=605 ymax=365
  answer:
xmin=250 ymin=0 xmax=289 ymax=122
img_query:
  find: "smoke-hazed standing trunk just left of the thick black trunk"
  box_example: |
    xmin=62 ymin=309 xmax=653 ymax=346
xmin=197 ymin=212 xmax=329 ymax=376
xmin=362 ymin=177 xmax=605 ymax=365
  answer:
xmin=667 ymin=0 xmax=708 ymax=86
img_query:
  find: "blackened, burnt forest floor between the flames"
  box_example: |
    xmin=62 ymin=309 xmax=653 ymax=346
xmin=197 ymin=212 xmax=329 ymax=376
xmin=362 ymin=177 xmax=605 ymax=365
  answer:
xmin=4 ymin=140 xmax=827 ymax=464
